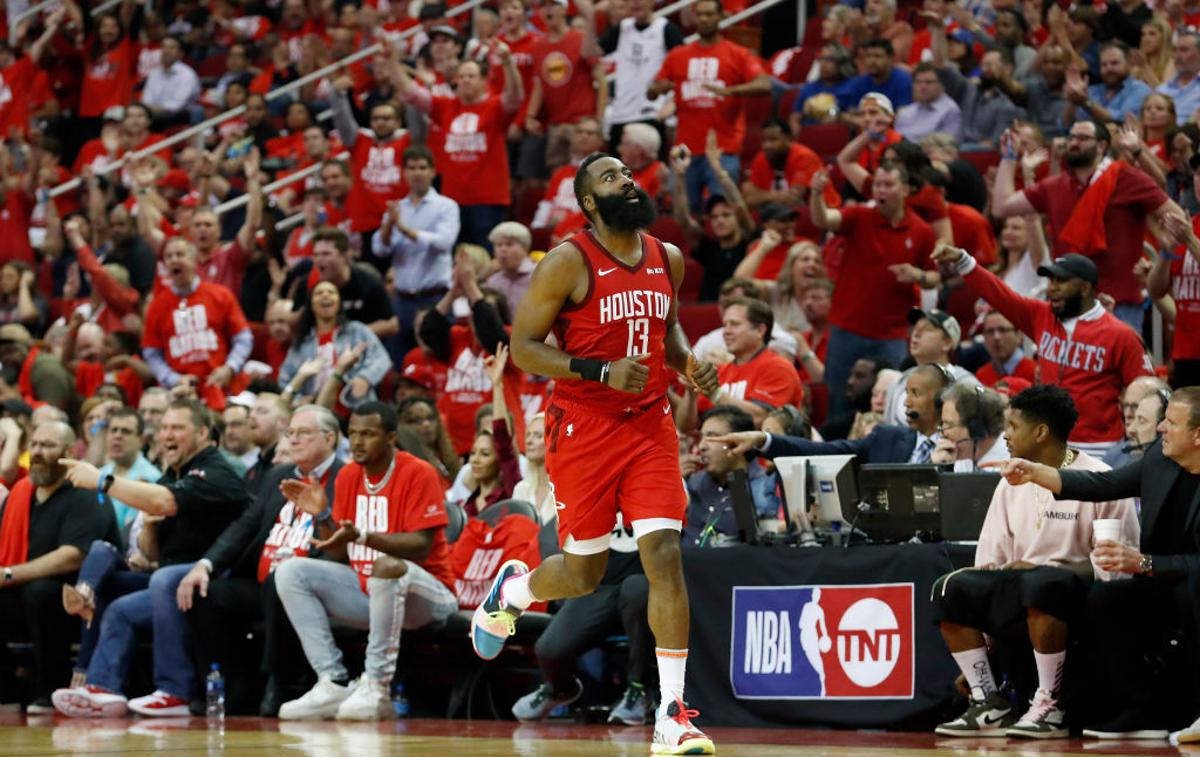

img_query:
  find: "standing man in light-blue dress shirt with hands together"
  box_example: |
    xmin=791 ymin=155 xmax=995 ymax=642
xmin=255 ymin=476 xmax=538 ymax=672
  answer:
xmin=371 ymin=145 xmax=461 ymax=365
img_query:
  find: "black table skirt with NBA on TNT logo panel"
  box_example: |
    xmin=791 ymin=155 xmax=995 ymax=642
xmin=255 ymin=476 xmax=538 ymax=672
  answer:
xmin=684 ymin=543 xmax=974 ymax=727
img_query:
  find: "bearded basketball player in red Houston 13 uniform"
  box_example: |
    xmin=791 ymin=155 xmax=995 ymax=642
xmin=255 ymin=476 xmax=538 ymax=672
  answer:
xmin=472 ymin=152 xmax=718 ymax=755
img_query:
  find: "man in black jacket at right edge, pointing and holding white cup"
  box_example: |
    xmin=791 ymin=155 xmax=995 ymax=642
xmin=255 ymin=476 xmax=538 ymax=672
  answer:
xmin=1000 ymin=386 xmax=1200 ymax=739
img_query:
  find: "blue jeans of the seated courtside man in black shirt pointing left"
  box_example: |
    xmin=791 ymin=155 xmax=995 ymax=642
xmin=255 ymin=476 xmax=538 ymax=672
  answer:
xmin=88 ymin=563 xmax=198 ymax=699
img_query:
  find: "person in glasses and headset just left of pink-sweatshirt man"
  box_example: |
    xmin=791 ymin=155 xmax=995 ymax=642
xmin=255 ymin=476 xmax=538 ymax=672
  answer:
xmin=930 ymin=383 xmax=1008 ymax=473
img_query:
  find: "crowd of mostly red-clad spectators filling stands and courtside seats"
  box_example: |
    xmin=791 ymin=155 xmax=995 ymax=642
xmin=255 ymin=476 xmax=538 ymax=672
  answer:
xmin=0 ymin=0 xmax=1200 ymax=738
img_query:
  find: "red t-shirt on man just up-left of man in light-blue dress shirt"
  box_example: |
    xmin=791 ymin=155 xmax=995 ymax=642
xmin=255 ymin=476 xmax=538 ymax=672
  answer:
xmin=346 ymin=128 xmax=412 ymax=232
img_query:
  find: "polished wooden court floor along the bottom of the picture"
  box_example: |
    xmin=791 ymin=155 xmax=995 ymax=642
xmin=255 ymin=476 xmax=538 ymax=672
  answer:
xmin=0 ymin=714 xmax=1200 ymax=757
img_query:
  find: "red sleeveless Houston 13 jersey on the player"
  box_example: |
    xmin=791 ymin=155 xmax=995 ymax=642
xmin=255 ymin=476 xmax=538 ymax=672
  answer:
xmin=551 ymin=229 xmax=674 ymax=415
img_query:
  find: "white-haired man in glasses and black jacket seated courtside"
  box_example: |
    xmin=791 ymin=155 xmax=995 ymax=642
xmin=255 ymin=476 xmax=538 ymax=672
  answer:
xmin=176 ymin=404 xmax=342 ymax=717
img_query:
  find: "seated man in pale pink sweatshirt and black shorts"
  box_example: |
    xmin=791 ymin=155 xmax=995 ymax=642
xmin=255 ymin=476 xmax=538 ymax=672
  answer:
xmin=932 ymin=385 xmax=1140 ymax=739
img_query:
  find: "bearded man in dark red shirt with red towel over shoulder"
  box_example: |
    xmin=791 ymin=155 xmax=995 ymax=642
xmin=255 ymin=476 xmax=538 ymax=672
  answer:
xmin=992 ymin=120 xmax=1187 ymax=334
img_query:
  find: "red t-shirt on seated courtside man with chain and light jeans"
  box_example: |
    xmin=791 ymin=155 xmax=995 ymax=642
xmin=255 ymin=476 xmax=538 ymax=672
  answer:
xmin=334 ymin=451 xmax=454 ymax=591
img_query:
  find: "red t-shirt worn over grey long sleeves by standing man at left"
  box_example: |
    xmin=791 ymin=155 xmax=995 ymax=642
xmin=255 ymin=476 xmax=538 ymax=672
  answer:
xmin=142 ymin=282 xmax=250 ymax=378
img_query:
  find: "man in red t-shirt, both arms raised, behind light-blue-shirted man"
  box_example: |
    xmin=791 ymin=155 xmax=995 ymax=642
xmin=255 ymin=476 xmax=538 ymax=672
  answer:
xmin=400 ymin=42 xmax=524 ymax=250
